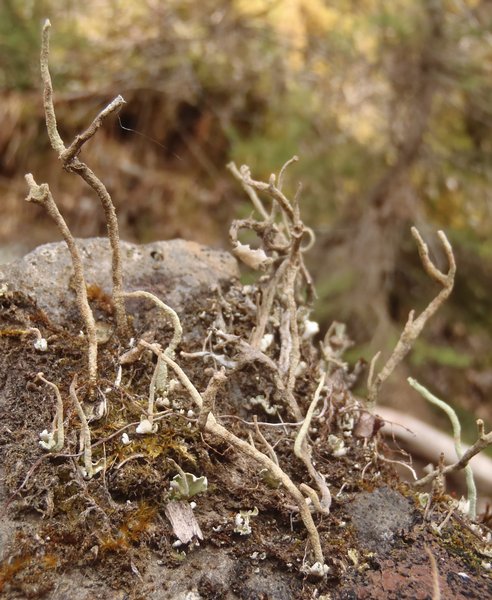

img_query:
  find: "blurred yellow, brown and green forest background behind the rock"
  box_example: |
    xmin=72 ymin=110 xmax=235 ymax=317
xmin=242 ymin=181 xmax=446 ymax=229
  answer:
xmin=0 ymin=0 xmax=492 ymax=434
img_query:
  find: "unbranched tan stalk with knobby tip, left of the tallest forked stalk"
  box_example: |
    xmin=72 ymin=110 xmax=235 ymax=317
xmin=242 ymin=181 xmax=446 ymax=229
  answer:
xmin=25 ymin=173 xmax=97 ymax=386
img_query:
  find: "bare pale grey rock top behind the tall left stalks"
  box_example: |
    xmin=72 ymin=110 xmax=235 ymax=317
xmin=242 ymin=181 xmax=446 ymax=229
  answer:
xmin=0 ymin=238 xmax=239 ymax=324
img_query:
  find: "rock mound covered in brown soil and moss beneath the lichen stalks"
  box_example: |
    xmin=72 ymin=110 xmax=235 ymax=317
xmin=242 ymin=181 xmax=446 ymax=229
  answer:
xmin=0 ymin=240 xmax=492 ymax=600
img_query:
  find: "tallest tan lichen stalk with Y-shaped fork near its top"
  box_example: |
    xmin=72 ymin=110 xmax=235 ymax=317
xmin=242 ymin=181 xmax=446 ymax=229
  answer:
xmin=41 ymin=19 xmax=129 ymax=337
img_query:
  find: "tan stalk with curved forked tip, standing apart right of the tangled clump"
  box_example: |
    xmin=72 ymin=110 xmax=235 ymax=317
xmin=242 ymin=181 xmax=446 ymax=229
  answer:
xmin=367 ymin=227 xmax=456 ymax=408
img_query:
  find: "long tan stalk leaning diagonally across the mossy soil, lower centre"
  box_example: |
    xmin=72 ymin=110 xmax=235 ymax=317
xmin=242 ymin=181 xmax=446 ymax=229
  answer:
xmin=151 ymin=346 xmax=324 ymax=564
